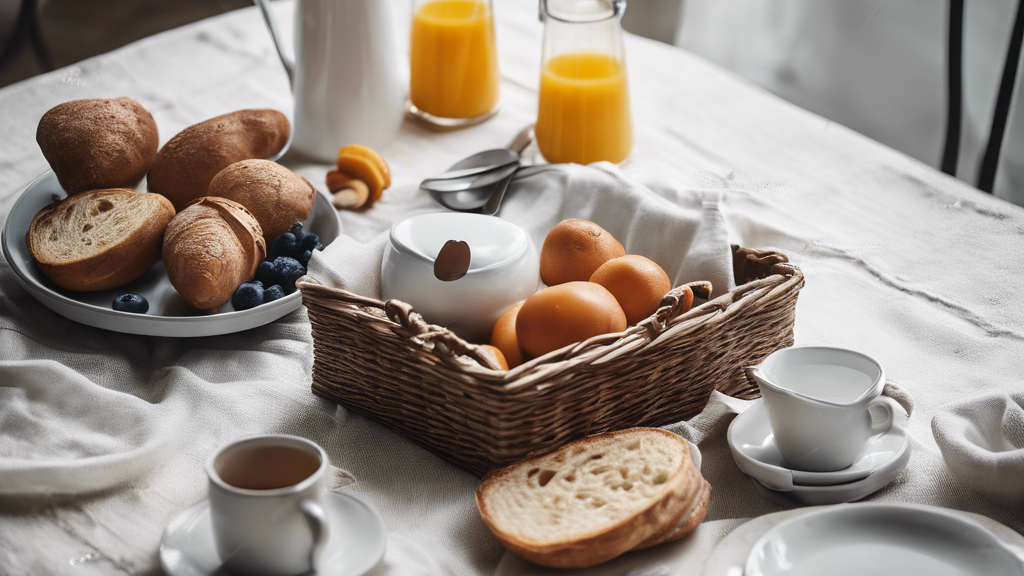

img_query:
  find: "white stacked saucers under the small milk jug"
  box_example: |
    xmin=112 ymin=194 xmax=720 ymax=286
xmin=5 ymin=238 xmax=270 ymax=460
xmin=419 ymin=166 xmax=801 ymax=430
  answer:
xmin=727 ymin=400 xmax=910 ymax=504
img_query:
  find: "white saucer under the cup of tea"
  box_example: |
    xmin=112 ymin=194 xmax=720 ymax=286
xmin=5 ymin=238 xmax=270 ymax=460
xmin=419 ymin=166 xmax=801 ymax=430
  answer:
xmin=160 ymin=493 xmax=386 ymax=576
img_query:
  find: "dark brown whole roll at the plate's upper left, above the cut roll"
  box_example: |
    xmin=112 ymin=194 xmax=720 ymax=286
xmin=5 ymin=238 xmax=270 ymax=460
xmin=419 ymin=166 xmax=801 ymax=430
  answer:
xmin=36 ymin=97 xmax=160 ymax=194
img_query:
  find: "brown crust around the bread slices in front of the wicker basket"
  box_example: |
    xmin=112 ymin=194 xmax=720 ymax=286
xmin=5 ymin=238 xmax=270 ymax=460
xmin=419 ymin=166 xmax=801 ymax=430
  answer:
xmin=476 ymin=428 xmax=707 ymax=568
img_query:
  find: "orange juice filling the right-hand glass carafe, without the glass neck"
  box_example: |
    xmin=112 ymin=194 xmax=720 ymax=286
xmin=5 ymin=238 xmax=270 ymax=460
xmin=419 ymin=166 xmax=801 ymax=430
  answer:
xmin=535 ymin=52 xmax=633 ymax=164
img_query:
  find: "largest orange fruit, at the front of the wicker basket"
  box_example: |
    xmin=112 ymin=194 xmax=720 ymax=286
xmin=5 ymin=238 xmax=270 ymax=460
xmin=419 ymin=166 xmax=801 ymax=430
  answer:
xmin=515 ymin=282 xmax=626 ymax=356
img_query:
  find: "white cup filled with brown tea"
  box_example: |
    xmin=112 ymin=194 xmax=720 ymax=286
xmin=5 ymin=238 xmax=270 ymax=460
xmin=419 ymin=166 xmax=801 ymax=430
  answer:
xmin=206 ymin=435 xmax=330 ymax=576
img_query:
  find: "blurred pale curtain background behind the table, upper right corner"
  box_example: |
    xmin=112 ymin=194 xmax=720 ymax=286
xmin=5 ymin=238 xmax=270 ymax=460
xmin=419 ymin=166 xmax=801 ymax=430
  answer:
xmin=625 ymin=0 xmax=1024 ymax=205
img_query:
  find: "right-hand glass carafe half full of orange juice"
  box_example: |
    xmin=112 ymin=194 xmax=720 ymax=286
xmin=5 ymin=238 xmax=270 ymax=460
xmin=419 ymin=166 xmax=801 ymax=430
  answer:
xmin=535 ymin=0 xmax=633 ymax=164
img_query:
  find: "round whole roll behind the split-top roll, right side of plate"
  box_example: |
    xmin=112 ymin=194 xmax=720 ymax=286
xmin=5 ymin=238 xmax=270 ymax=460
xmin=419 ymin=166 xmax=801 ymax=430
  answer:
xmin=208 ymin=160 xmax=316 ymax=246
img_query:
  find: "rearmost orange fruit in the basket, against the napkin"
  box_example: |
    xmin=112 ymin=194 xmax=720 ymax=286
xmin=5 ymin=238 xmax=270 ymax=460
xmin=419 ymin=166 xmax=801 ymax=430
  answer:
xmin=541 ymin=219 xmax=626 ymax=286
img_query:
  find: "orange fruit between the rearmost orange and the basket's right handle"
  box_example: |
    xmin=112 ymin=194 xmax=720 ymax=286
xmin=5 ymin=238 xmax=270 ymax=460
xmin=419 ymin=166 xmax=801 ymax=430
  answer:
xmin=590 ymin=254 xmax=672 ymax=326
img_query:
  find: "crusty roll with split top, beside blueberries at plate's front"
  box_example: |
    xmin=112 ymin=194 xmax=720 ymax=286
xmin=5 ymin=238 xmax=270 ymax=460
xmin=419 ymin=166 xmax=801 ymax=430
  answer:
xmin=164 ymin=197 xmax=266 ymax=310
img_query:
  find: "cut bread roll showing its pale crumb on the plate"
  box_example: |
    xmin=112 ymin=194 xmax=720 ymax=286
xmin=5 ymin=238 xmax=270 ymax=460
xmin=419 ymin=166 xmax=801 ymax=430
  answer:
xmin=28 ymin=189 xmax=174 ymax=292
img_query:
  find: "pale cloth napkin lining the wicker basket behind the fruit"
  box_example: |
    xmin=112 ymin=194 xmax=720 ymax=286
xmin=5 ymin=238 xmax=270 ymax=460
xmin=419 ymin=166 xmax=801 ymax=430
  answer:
xmin=309 ymin=163 xmax=734 ymax=305
